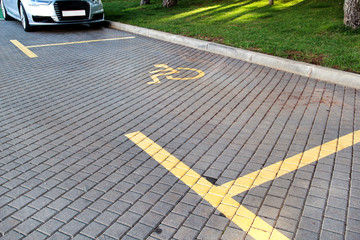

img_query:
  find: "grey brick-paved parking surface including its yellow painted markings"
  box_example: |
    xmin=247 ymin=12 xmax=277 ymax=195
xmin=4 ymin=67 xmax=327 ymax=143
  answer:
xmin=0 ymin=21 xmax=360 ymax=240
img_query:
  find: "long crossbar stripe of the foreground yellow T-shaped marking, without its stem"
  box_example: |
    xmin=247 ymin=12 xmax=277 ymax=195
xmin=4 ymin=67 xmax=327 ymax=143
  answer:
xmin=125 ymin=132 xmax=287 ymax=240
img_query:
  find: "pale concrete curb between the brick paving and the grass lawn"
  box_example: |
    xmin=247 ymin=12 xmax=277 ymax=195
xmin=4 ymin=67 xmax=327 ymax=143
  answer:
xmin=107 ymin=21 xmax=360 ymax=89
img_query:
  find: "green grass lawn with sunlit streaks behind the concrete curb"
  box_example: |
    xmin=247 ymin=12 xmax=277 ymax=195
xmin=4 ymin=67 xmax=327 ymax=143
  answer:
xmin=103 ymin=0 xmax=360 ymax=73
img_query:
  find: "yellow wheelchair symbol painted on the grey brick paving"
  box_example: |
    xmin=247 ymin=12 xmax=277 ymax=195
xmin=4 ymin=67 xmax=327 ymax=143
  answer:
xmin=147 ymin=64 xmax=205 ymax=84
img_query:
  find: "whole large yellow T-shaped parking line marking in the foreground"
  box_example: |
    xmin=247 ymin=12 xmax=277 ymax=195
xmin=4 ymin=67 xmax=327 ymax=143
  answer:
xmin=125 ymin=130 xmax=360 ymax=240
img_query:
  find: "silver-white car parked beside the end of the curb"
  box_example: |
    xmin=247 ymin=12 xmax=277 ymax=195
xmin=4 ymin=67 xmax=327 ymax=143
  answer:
xmin=0 ymin=0 xmax=104 ymax=31
